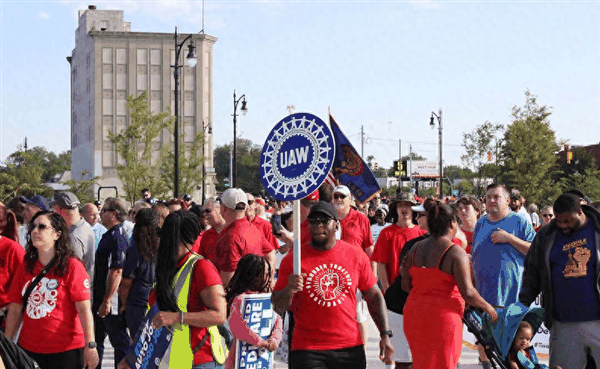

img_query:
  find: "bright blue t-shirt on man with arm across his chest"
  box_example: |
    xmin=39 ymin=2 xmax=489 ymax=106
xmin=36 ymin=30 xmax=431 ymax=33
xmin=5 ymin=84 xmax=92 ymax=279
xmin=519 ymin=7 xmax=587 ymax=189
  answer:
xmin=471 ymin=212 xmax=535 ymax=306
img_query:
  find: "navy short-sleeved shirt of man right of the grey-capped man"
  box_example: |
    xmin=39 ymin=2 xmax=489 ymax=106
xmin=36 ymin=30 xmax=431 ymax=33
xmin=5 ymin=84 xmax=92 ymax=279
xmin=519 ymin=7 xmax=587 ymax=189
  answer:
xmin=92 ymin=223 xmax=129 ymax=314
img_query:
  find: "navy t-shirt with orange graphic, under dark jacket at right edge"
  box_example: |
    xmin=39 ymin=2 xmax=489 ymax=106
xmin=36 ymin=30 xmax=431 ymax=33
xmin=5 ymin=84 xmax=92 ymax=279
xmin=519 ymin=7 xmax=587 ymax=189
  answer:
xmin=550 ymin=220 xmax=600 ymax=322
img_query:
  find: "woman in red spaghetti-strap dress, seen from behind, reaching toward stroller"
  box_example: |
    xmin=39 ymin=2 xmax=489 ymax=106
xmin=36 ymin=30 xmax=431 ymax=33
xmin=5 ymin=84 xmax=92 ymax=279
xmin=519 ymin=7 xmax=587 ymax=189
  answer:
xmin=401 ymin=202 xmax=498 ymax=369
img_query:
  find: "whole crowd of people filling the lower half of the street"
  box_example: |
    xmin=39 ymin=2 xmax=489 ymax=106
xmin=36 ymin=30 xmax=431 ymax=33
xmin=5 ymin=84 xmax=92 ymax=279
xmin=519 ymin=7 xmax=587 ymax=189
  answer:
xmin=0 ymin=184 xmax=600 ymax=369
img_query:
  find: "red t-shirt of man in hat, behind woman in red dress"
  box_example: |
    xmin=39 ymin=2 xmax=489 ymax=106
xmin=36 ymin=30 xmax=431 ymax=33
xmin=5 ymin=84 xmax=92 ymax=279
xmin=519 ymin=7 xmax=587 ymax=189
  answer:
xmin=371 ymin=223 xmax=427 ymax=283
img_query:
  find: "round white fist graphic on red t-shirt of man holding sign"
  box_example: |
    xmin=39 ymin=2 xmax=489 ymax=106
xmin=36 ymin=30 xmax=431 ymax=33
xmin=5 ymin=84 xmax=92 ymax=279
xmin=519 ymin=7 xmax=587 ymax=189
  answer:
xmin=306 ymin=264 xmax=352 ymax=307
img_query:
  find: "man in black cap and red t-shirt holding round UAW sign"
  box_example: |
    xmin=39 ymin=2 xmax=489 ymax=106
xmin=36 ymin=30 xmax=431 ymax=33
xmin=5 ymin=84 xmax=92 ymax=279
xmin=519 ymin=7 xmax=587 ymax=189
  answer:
xmin=271 ymin=201 xmax=393 ymax=369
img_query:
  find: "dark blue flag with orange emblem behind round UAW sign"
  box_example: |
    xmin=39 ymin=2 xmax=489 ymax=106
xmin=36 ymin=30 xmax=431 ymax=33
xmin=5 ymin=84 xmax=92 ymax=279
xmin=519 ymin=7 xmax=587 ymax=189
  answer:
xmin=329 ymin=114 xmax=381 ymax=203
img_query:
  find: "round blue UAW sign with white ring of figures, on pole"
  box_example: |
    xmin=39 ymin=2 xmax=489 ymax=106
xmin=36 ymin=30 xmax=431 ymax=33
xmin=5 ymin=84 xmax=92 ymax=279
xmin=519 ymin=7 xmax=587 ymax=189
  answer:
xmin=260 ymin=113 xmax=335 ymax=201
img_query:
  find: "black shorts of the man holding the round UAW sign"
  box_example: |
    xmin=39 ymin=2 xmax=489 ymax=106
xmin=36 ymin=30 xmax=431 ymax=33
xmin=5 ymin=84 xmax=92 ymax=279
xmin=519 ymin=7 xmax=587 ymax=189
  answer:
xmin=288 ymin=345 xmax=367 ymax=369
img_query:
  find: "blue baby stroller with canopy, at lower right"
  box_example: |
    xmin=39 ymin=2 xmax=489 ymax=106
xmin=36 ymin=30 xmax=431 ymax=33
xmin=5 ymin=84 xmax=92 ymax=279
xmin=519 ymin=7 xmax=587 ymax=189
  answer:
xmin=463 ymin=302 xmax=548 ymax=369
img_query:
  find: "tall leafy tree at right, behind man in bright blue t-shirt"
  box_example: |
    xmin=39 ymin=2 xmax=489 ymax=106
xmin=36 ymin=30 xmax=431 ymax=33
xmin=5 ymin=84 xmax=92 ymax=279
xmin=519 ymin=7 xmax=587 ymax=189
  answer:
xmin=501 ymin=91 xmax=558 ymax=203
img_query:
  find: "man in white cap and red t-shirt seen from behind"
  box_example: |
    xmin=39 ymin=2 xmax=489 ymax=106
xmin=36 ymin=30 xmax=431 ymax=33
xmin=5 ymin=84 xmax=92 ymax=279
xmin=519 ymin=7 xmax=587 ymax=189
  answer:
xmin=213 ymin=188 xmax=274 ymax=286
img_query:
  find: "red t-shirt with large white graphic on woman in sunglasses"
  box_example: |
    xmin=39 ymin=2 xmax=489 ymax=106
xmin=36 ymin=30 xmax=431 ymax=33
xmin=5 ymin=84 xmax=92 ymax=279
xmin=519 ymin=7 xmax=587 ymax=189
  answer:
xmin=8 ymin=258 xmax=91 ymax=354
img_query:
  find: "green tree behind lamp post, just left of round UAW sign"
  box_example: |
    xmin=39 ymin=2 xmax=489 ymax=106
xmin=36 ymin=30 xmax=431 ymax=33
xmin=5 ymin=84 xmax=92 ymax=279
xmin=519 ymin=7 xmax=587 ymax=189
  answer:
xmin=214 ymin=138 xmax=265 ymax=194
